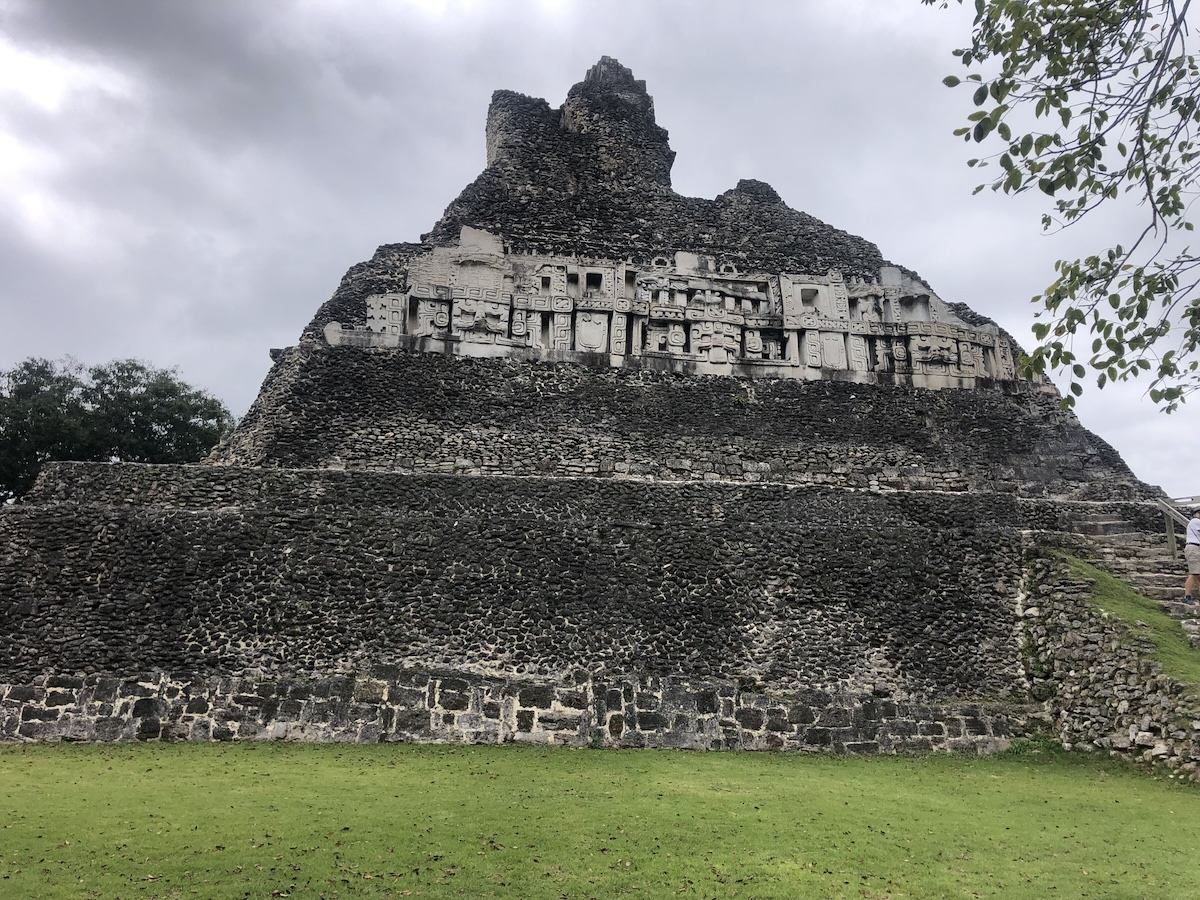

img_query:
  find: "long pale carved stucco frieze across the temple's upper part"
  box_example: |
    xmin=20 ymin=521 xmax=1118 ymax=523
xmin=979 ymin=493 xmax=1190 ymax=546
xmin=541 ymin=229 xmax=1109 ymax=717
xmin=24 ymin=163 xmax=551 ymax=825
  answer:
xmin=328 ymin=229 xmax=1015 ymax=385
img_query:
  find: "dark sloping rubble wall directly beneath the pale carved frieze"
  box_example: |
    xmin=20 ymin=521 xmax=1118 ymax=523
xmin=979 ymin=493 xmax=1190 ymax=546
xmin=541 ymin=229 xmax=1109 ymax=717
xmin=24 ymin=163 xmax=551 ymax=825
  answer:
xmin=212 ymin=347 xmax=1159 ymax=499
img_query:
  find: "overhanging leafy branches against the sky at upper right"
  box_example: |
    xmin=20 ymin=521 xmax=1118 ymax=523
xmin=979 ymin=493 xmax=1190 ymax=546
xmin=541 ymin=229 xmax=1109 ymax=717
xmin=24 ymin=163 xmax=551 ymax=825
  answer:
xmin=922 ymin=0 xmax=1200 ymax=412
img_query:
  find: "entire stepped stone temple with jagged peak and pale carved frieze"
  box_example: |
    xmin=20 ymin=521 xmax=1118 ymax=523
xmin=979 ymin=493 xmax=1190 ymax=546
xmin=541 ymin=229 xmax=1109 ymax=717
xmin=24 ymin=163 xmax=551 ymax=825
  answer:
xmin=0 ymin=58 xmax=1200 ymax=770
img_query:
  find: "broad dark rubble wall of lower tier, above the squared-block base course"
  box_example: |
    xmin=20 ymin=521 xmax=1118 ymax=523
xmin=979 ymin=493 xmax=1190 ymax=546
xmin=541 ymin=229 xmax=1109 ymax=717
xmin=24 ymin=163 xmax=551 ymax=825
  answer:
xmin=0 ymin=463 xmax=1028 ymax=701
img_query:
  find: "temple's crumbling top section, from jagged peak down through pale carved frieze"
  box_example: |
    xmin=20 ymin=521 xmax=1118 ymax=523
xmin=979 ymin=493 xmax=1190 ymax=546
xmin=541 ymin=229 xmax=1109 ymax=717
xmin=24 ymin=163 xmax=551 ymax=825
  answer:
xmin=306 ymin=56 xmax=1022 ymax=388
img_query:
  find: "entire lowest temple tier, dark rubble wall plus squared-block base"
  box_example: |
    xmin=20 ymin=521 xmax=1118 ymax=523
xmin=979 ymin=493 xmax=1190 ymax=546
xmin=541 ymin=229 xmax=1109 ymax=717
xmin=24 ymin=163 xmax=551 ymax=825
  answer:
xmin=7 ymin=463 xmax=1200 ymax=774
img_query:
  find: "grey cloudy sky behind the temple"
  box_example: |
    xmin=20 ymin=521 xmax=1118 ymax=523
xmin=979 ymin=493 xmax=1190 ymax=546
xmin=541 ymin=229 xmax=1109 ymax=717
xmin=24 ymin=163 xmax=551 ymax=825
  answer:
xmin=0 ymin=0 xmax=1200 ymax=496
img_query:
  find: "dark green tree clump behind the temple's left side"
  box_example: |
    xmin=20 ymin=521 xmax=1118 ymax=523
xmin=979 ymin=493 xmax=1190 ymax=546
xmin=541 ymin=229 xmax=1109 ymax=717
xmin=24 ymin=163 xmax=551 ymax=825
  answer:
xmin=0 ymin=359 xmax=233 ymax=503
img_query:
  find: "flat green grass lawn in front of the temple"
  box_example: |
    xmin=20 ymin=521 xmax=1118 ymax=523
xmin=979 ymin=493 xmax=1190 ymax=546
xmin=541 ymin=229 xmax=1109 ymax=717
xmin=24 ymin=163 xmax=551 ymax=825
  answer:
xmin=0 ymin=743 xmax=1200 ymax=898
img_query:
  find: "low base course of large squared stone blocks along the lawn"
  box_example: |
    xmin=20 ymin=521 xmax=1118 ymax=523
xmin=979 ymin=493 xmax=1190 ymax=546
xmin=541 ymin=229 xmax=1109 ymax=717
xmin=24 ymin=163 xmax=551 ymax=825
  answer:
xmin=0 ymin=671 xmax=1034 ymax=752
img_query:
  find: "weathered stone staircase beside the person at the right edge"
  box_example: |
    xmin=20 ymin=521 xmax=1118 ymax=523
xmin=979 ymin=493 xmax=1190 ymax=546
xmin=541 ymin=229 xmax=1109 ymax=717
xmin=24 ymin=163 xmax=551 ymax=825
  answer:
xmin=1074 ymin=514 xmax=1200 ymax=649
